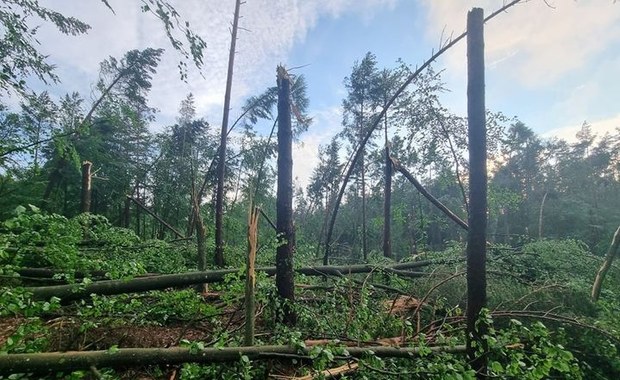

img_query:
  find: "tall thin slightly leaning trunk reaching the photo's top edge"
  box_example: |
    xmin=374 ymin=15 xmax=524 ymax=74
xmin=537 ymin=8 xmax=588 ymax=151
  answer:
xmin=215 ymin=0 xmax=241 ymax=267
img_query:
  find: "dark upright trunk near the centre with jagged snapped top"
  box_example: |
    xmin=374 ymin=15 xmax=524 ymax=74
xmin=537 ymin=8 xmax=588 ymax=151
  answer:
xmin=276 ymin=66 xmax=297 ymax=325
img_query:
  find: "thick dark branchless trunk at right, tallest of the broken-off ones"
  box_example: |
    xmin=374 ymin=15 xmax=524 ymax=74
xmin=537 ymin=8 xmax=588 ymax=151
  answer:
xmin=467 ymin=8 xmax=487 ymax=378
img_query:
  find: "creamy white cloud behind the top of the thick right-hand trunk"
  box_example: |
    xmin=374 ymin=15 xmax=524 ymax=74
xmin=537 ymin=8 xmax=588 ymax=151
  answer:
xmin=424 ymin=0 xmax=620 ymax=87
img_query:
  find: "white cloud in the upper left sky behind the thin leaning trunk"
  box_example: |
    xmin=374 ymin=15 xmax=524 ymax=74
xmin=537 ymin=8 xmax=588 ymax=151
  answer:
xmin=30 ymin=0 xmax=395 ymax=128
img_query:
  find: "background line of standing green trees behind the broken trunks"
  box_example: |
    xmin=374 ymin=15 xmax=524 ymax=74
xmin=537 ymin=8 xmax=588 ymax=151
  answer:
xmin=0 ymin=49 xmax=620 ymax=261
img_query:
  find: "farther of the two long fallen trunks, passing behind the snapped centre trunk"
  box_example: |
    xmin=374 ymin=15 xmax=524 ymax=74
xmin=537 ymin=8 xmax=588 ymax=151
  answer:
xmin=25 ymin=260 xmax=441 ymax=301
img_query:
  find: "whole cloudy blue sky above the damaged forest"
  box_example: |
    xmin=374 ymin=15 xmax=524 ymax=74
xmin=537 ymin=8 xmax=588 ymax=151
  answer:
xmin=13 ymin=0 xmax=620 ymax=186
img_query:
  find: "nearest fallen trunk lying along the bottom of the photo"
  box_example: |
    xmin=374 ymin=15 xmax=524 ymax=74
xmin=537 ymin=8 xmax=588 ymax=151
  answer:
xmin=0 ymin=346 xmax=465 ymax=374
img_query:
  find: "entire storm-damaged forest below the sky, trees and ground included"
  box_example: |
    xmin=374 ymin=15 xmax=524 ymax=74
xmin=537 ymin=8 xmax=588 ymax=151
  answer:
xmin=0 ymin=0 xmax=620 ymax=380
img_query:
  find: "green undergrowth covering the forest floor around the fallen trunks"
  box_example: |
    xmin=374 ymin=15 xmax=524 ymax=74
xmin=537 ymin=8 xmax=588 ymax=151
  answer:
xmin=0 ymin=207 xmax=620 ymax=379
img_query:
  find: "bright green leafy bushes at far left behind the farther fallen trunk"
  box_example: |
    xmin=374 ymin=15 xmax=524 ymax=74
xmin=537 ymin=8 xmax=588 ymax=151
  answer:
xmin=0 ymin=206 xmax=195 ymax=281
